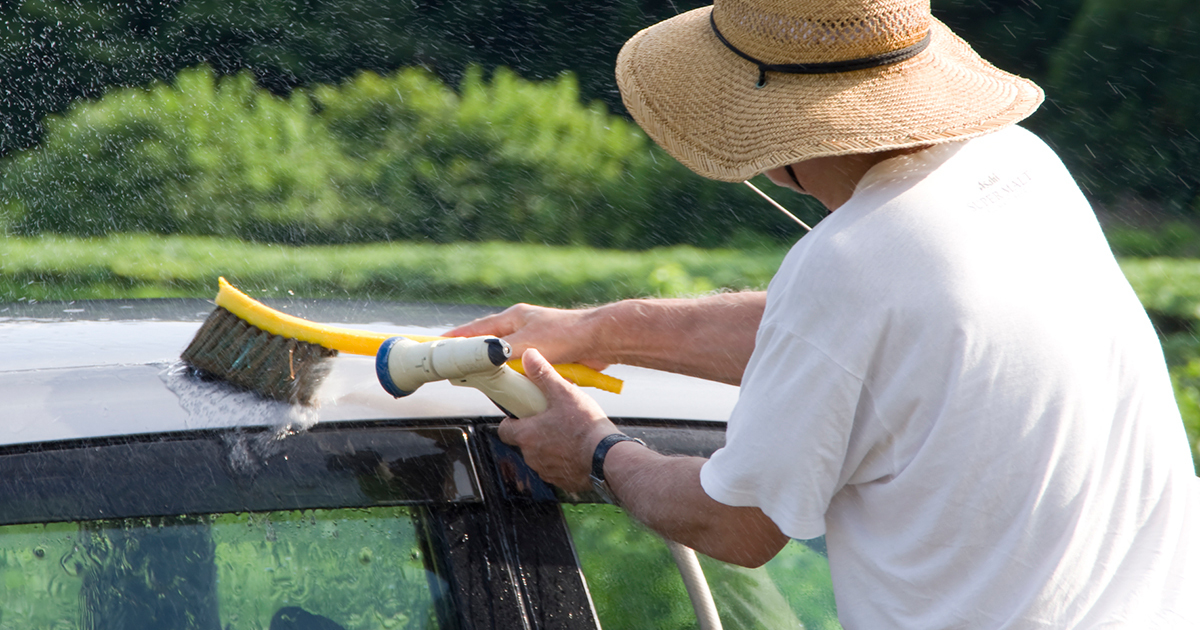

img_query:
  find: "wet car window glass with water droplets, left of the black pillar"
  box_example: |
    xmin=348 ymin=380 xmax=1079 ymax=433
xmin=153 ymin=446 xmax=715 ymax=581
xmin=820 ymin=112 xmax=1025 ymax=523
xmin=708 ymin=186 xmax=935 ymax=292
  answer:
xmin=0 ymin=508 xmax=442 ymax=630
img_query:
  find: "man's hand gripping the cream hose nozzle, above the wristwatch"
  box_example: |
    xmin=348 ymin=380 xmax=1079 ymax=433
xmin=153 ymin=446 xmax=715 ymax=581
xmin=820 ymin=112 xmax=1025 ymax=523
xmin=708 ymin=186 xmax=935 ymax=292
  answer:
xmin=499 ymin=349 xmax=619 ymax=492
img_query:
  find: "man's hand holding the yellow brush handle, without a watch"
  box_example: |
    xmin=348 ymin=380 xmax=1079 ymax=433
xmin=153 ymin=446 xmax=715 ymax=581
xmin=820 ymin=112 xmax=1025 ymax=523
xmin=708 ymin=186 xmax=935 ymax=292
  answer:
xmin=445 ymin=304 xmax=608 ymax=370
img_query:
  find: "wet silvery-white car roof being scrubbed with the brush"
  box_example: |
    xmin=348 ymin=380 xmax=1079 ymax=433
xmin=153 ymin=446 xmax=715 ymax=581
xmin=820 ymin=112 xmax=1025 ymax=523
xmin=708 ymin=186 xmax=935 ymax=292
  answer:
xmin=0 ymin=299 xmax=738 ymax=445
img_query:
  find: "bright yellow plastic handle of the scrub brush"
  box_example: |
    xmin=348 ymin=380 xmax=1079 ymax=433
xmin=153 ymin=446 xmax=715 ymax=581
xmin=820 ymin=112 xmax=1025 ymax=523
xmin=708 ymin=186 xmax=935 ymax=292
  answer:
xmin=217 ymin=277 xmax=624 ymax=394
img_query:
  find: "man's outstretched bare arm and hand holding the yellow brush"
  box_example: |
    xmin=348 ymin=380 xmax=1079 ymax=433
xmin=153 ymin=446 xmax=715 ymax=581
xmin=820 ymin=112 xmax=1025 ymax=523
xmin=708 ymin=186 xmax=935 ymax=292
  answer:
xmin=446 ymin=292 xmax=767 ymax=385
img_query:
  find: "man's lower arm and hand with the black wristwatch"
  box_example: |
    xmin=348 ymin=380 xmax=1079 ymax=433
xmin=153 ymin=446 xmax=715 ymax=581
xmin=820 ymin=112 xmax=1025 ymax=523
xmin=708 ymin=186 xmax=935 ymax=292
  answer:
xmin=500 ymin=350 xmax=787 ymax=566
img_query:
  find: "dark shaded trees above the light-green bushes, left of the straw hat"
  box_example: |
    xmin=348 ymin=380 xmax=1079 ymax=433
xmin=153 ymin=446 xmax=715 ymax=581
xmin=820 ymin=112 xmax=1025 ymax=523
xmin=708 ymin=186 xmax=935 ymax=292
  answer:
xmin=0 ymin=0 xmax=707 ymax=154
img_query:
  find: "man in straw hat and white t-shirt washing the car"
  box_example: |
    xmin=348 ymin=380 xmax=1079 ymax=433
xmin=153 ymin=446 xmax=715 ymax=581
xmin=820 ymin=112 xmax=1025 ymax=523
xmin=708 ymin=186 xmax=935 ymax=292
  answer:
xmin=451 ymin=0 xmax=1200 ymax=629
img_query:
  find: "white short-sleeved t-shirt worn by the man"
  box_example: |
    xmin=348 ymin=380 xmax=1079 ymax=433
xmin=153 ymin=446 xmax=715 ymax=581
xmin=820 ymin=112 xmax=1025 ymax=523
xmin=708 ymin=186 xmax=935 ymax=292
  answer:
xmin=701 ymin=127 xmax=1200 ymax=630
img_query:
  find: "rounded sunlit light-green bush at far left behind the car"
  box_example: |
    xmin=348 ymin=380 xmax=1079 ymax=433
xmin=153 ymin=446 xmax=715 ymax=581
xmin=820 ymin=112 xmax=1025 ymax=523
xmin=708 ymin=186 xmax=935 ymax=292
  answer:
xmin=4 ymin=70 xmax=372 ymax=240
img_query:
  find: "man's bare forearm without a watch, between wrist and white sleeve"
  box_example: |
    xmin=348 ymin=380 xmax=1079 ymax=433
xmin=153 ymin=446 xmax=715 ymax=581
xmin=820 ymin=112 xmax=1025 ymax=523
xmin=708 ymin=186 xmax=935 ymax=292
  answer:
xmin=588 ymin=292 xmax=767 ymax=385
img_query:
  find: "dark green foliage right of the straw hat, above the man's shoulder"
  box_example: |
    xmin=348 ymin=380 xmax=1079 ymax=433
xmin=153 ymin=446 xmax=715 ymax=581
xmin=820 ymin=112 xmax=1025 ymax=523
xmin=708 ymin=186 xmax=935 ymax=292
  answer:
xmin=932 ymin=0 xmax=1200 ymax=216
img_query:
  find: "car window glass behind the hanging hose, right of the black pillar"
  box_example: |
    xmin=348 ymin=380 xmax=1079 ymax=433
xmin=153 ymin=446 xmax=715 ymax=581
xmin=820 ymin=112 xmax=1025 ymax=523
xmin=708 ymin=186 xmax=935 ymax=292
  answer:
xmin=563 ymin=504 xmax=841 ymax=630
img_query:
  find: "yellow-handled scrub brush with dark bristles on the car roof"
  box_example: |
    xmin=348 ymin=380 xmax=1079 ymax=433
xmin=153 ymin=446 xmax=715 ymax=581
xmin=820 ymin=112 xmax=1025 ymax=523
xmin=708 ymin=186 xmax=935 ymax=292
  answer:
xmin=181 ymin=277 xmax=623 ymax=404
